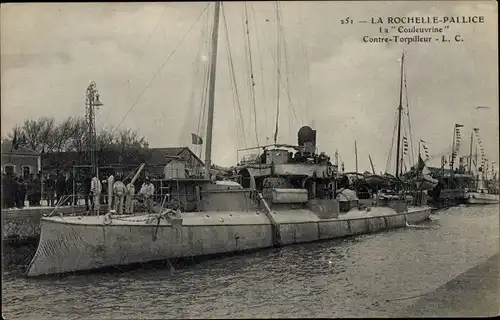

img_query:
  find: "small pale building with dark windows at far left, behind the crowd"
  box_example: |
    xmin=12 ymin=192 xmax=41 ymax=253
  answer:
xmin=2 ymin=141 xmax=41 ymax=179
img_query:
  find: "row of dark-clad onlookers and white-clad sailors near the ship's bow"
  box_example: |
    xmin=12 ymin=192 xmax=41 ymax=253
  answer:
xmin=1 ymin=172 xmax=155 ymax=214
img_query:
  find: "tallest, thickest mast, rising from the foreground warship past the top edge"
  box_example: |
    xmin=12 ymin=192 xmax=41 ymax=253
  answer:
xmin=205 ymin=1 xmax=220 ymax=179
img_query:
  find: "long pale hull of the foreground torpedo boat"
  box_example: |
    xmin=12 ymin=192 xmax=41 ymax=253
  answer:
xmin=28 ymin=206 xmax=431 ymax=276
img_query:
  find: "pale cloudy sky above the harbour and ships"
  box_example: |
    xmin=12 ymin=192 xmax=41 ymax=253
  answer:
xmin=1 ymin=1 xmax=499 ymax=172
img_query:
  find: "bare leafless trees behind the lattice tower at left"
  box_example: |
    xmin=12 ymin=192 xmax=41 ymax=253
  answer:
xmin=7 ymin=117 xmax=147 ymax=152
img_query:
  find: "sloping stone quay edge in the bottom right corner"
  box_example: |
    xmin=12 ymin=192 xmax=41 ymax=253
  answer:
xmin=391 ymin=253 xmax=500 ymax=318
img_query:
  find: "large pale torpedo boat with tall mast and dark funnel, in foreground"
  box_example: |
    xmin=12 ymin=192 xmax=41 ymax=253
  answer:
xmin=27 ymin=2 xmax=430 ymax=276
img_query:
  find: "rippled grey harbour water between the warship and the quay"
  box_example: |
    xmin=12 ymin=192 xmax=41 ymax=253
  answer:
xmin=2 ymin=205 xmax=499 ymax=319
